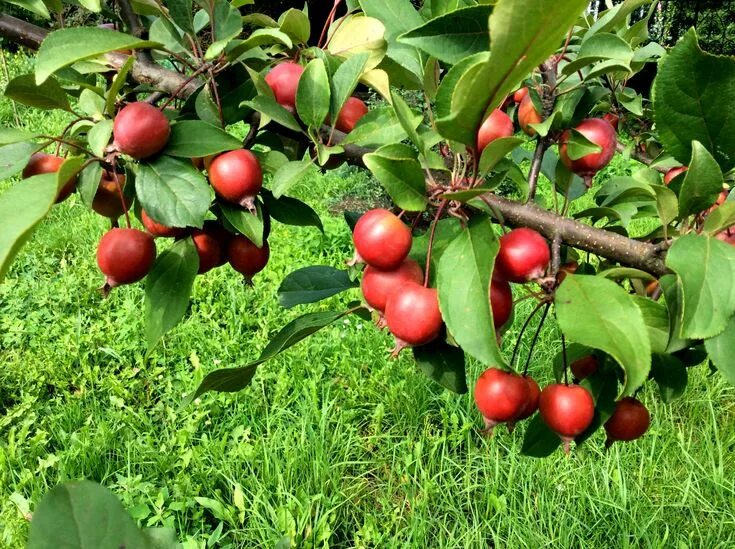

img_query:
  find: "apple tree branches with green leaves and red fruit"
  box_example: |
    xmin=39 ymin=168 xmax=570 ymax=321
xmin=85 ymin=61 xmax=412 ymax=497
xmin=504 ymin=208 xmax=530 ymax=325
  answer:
xmin=0 ymin=0 xmax=735 ymax=457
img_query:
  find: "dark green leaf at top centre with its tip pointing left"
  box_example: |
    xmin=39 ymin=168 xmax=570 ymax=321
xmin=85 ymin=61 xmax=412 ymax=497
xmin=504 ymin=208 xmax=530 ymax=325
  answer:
xmin=398 ymin=6 xmax=493 ymax=65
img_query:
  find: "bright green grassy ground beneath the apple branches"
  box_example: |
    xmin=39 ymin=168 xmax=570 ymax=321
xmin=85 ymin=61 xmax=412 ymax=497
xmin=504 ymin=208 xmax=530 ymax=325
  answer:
xmin=0 ymin=52 xmax=735 ymax=548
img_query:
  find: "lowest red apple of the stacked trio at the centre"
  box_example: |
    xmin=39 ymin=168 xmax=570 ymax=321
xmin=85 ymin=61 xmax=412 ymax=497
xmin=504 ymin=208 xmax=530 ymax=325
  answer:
xmin=385 ymin=282 xmax=444 ymax=355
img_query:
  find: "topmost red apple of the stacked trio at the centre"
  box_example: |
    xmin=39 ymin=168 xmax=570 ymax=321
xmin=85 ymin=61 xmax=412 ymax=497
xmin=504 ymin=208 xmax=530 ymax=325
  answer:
xmin=352 ymin=208 xmax=413 ymax=271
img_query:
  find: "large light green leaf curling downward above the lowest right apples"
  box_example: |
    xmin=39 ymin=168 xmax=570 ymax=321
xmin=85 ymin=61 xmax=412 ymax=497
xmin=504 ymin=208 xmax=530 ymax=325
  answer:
xmin=554 ymin=275 xmax=651 ymax=396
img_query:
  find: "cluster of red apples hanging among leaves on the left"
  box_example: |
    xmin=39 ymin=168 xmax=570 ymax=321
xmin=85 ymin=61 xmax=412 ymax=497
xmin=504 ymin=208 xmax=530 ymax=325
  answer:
xmin=23 ymin=102 xmax=270 ymax=287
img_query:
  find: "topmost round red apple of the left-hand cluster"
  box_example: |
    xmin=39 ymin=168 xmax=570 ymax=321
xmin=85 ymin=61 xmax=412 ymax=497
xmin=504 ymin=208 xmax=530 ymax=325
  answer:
xmin=112 ymin=101 xmax=171 ymax=160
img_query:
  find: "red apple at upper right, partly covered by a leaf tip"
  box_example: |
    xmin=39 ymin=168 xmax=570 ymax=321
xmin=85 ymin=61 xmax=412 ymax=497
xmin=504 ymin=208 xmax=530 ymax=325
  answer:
xmin=559 ymin=118 xmax=618 ymax=178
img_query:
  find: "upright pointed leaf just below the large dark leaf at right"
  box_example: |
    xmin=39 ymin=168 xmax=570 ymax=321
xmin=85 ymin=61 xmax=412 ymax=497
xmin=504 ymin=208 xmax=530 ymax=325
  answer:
xmin=679 ymin=141 xmax=723 ymax=218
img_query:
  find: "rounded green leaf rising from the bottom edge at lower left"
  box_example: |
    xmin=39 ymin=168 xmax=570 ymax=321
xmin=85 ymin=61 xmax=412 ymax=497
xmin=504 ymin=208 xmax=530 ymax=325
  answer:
xmin=28 ymin=480 xmax=151 ymax=549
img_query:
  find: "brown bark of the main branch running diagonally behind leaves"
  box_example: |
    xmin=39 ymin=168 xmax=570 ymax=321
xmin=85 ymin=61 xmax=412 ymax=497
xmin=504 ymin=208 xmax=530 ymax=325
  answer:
xmin=0 ymin=14 xmax=669 ymax=276
